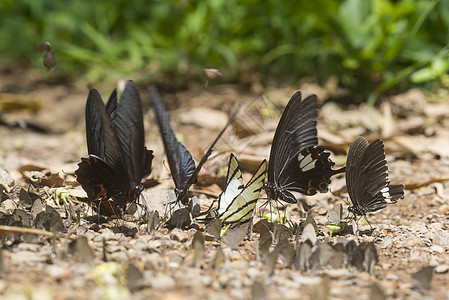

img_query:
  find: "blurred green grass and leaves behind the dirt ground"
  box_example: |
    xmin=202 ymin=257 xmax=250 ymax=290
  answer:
xmin=0 ymin=0 xmax=449 ymax=104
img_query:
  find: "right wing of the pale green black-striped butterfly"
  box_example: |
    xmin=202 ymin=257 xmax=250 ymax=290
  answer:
xmin=219 ymin=160 xmax=267 ymax=223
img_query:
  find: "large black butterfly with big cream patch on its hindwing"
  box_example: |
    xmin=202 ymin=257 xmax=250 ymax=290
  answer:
xmin=264 ymin=92 xmax=345 ymax=203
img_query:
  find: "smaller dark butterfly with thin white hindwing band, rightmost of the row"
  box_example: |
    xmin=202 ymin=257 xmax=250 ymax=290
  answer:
xmin=346 ymin=137 xmax=405 ymax=216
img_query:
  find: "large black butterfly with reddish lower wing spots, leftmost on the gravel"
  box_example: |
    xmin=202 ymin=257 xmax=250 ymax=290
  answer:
xmin=75 ymin=81 xmax=153 ymax=215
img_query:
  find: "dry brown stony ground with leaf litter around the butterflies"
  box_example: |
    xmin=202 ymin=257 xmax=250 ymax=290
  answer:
xmin=0 ymin=72 xmax=449 ymax=299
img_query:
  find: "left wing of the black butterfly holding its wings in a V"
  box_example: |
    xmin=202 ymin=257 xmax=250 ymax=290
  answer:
xmin=148 ymin=86 xmax=195 ymax=196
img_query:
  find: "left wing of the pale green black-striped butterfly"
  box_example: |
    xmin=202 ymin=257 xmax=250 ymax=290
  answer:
xmin=217 ymin=154 xmax=243 ymax=215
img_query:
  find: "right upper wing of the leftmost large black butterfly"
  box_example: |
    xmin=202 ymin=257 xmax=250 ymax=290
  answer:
xmin=108 ymin=80 xmax=153 ymax=189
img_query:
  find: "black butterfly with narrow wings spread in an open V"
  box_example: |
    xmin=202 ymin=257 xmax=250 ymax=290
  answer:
xmin=148 ymin=86 xmax=239 ymax=205
